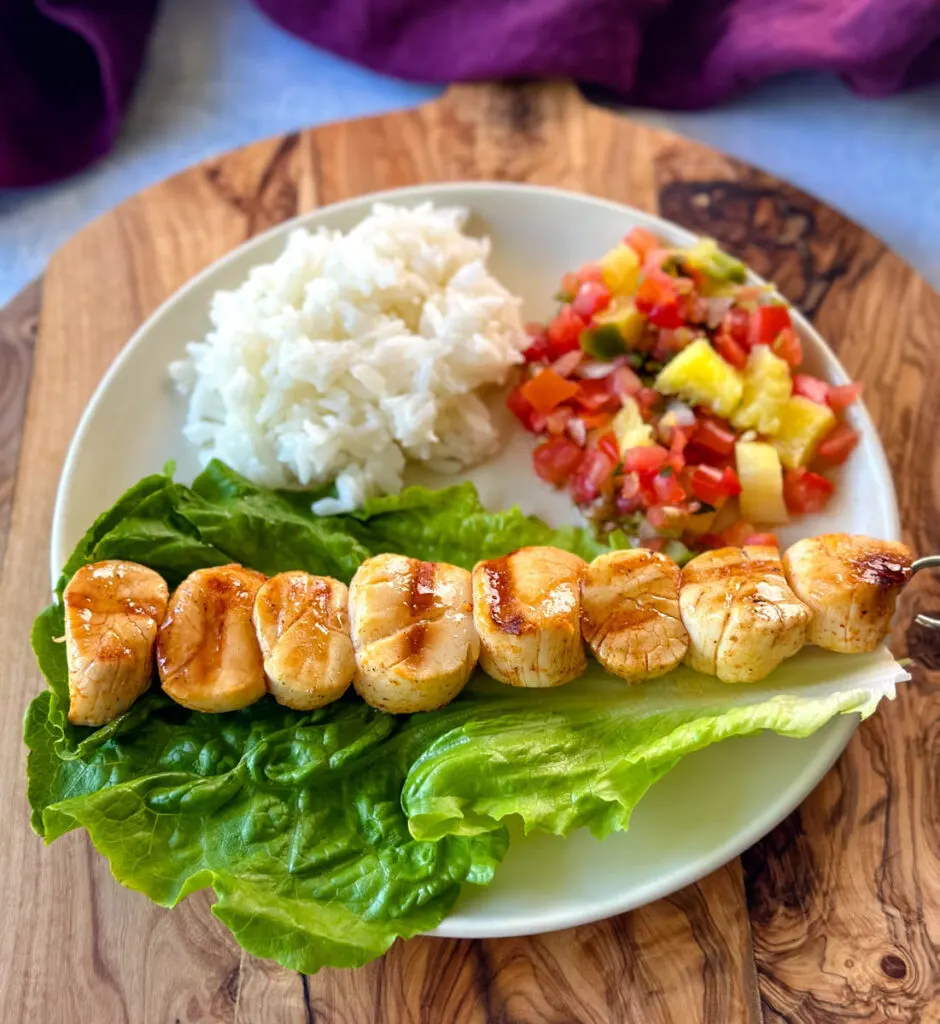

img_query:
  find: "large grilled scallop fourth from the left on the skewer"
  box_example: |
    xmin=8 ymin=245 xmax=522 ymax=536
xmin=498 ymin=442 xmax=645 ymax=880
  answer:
xmin=349 ymin=555 xmax=480 ymax=715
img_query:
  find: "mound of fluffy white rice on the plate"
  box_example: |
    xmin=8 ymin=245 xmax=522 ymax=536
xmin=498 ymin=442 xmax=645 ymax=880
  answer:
xmin=170 ymin=203 xmax=527 ymax=515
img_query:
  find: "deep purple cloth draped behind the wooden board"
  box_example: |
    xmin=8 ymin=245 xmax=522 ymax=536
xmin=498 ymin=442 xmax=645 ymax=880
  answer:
xmin=0 ymin=0 xmax=940 ymax=187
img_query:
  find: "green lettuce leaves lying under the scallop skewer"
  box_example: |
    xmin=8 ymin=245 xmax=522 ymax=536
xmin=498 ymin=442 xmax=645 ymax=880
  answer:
xmin=25 ymin=463 xmax=896 ymax=972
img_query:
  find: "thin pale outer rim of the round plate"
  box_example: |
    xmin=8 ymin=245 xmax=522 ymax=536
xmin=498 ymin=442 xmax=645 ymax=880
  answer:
xmin=49 ymin=180 xmax=901 ymax=939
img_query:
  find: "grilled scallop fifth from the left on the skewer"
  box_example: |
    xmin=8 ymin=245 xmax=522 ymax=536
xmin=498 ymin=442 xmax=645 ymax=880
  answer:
xmin=473 ymin=548 xmax=587 ymax=687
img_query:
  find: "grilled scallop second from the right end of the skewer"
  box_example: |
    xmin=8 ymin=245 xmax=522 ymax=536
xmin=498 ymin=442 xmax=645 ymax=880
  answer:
xmin=679 ymin=546 xmax=811 ymax=683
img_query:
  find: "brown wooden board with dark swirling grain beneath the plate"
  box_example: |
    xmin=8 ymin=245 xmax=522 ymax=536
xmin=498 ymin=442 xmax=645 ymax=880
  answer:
xmin=0 ymin=84 xmax=940 ymax=1024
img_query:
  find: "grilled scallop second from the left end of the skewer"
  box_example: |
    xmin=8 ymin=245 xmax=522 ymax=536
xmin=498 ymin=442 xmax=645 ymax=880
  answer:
xmin=157 ymin=565 xmax=265 ymax=712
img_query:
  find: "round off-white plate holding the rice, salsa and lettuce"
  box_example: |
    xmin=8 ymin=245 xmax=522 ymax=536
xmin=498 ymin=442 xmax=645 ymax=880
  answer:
xmin=51 ymin=183 xmax=899 ymax=938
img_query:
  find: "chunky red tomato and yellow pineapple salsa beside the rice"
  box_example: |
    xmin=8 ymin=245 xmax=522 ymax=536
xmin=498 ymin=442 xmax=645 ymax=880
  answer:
xmin=507 ymin=228 xmax=860 ymax=561
